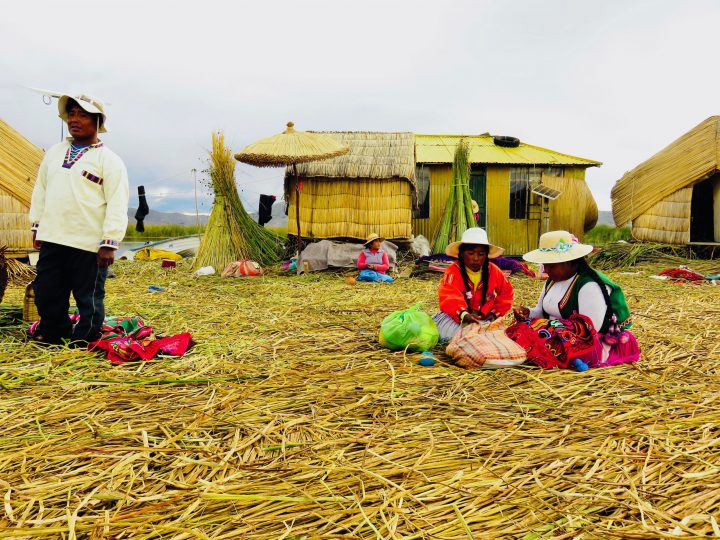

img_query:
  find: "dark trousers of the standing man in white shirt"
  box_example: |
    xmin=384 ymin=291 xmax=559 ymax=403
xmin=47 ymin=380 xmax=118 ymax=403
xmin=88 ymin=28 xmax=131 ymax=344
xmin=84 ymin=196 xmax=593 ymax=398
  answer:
xmin=34 ymin=242 xmax=107 ymax=343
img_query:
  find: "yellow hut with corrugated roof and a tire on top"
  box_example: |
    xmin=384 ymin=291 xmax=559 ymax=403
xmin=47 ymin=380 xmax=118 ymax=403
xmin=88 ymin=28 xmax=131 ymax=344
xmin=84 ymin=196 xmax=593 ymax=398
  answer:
xmin=412 ymin=134 xmax=601 ymax=255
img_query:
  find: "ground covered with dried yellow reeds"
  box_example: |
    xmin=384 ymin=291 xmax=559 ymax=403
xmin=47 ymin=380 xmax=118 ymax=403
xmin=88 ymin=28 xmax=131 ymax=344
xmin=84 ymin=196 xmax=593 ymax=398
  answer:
xmin=0 ymin=262 xmax=720 ymax=539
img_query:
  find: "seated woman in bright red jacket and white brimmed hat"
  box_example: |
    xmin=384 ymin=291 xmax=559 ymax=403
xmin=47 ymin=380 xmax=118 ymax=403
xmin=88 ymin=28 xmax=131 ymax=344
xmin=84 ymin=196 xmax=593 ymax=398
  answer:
xmin=433 ymin=227 xmax=514 ymax=340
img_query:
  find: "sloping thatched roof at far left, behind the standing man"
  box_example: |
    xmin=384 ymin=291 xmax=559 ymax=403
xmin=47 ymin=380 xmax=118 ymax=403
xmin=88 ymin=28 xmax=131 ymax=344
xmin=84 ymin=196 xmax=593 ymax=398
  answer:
xmin=0 ymin=119 xmax=43 ymax=210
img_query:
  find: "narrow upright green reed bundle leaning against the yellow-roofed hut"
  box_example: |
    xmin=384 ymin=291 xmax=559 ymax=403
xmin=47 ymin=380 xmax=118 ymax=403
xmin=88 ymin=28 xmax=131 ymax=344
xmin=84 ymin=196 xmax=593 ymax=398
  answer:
xmin=433 ymin=140 xmax=475 ymax=253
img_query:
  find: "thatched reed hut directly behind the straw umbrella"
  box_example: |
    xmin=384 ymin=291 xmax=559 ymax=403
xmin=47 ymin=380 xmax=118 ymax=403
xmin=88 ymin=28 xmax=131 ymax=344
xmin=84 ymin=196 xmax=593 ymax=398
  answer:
xmin=285 ymin=131 xmax=416 ymax=241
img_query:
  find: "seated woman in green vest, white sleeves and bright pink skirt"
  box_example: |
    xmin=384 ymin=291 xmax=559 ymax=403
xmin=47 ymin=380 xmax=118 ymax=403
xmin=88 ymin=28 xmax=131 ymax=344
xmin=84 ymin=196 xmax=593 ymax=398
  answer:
xmin=508 ymin=231 xmax=640 ymax=370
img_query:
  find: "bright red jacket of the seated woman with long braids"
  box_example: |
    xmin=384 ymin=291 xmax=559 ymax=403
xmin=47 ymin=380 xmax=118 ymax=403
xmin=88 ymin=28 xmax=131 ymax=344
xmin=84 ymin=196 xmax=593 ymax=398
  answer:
xmin=438 ymin=262 xmax=515 ymax=323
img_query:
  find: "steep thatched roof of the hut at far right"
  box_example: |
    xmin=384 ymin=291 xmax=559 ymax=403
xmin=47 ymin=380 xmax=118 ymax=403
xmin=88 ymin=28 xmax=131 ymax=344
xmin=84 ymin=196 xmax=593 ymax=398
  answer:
xmin=611 ymin=116 xmax=720 ymax=225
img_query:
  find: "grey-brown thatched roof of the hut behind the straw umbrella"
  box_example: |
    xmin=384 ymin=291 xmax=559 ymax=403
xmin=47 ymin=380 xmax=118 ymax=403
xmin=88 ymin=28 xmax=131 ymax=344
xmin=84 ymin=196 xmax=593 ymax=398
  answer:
xmin=286 ymin=131 xmax=415 ymax=182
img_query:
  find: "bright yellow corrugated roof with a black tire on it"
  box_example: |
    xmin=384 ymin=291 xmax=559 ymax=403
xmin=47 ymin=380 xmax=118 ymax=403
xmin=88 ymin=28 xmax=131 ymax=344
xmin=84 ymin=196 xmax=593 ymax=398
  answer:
xmin=415 ymin=134 xmax=602 ymax=167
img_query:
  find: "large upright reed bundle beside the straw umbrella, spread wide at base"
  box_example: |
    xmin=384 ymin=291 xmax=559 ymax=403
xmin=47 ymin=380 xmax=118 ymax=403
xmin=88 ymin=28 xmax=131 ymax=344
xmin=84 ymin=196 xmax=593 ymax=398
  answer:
xmin=193 ymin=132 xmax=283 ymax=271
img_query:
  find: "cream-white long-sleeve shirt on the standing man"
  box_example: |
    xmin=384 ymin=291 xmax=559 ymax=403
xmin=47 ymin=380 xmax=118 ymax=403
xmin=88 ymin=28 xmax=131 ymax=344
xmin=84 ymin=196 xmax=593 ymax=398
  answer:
xmin=30 ymin=139 xmax=130 ymax=252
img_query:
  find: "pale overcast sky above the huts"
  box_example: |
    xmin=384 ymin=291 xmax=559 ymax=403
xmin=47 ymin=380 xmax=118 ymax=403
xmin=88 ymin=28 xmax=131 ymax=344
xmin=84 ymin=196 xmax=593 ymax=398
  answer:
xmin=0 ymin=0 xmax=720 ymax=217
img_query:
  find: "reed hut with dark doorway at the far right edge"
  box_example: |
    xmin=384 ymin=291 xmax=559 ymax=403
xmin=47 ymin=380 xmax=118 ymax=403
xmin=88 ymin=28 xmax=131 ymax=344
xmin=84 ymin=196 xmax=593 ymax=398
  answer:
xmin=611 ymin=116 xmax=720 ymax=245
